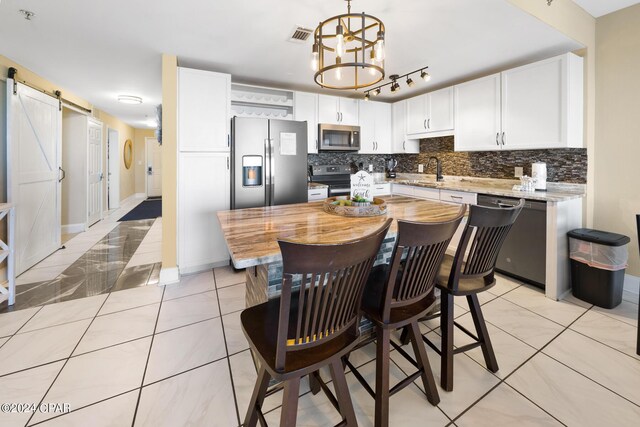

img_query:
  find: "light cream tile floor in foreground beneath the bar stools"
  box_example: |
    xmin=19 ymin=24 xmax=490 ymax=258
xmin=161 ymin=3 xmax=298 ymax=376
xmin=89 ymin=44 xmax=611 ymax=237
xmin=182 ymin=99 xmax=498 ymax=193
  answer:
xmin=0 ymin=267 xmax=640 ymax=427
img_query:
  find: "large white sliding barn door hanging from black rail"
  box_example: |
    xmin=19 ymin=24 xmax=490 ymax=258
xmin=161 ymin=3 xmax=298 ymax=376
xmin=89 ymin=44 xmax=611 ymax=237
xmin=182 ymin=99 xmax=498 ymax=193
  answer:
xmin=7 ymin=79 xmax=62 ymax=275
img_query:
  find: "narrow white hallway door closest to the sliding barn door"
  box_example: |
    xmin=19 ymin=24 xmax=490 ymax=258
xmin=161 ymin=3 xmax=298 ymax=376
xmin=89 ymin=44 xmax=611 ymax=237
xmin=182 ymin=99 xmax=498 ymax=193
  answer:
xmin=87 ymin=119 xmax=104 ymax=226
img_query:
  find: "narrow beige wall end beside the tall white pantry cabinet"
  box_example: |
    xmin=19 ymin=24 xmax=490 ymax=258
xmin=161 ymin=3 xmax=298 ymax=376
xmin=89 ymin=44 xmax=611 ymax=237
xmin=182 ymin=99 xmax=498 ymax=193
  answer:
xmin=162 ymin=54 xmax=178 ymax=269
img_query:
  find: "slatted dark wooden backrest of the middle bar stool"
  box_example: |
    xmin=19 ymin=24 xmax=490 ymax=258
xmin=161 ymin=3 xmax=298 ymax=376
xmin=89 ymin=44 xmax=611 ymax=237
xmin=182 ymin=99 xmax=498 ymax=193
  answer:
xmin=381 ymin=205 xmax=467 ymax=322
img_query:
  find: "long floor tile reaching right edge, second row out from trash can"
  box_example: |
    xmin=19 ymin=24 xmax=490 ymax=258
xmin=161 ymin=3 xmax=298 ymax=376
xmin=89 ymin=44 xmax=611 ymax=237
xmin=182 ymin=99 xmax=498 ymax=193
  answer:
xmin=542 ymin=330 xmax=640 ymax=406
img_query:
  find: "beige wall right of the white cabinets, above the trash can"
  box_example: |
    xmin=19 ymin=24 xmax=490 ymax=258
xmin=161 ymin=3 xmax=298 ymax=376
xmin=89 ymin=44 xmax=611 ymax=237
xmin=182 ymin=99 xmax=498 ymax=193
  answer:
xmin=594 ymin=5 xmax=640 ymax=276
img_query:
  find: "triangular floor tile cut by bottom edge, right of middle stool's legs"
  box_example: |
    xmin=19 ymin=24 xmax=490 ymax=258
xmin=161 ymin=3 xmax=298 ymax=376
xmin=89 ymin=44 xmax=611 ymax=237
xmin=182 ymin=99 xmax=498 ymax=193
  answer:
xmin=456 ymin=383 xmax=562 ymax=427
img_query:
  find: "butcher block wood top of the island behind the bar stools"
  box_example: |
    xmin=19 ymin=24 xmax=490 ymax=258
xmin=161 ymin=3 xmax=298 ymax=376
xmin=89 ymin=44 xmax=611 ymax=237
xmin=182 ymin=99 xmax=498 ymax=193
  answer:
xmin=218 ymin=196 xmax=460 ymax=268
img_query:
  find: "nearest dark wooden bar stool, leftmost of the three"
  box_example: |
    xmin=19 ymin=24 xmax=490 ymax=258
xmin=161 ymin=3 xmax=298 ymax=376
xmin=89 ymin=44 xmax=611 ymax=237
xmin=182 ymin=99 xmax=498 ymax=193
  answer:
xmin=240 ymin=219 xmax=392 ymax=427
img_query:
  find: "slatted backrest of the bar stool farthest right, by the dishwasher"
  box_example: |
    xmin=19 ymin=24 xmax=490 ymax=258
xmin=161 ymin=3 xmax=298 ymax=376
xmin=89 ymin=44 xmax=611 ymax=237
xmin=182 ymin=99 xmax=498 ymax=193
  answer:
xmin=448 ymin=199 xmax=526 ymax=291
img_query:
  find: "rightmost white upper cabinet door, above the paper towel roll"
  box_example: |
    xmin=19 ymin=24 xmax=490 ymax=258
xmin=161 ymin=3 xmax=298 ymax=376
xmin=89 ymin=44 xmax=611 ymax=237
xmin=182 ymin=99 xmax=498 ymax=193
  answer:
xmin=501 ymin=55 xmax=567 ymax=150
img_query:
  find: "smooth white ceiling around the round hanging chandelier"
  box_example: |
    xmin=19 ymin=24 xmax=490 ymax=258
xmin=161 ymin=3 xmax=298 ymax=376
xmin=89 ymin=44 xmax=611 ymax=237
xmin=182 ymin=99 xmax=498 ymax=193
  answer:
xmin=0 ymin=0 xmax=580 ymax=127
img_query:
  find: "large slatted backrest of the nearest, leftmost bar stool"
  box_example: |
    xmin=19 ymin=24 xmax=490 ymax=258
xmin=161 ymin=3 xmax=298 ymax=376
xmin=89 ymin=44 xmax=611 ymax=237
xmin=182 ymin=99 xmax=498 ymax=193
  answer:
xmin=276 ymin=218 xmax=393 ymax=369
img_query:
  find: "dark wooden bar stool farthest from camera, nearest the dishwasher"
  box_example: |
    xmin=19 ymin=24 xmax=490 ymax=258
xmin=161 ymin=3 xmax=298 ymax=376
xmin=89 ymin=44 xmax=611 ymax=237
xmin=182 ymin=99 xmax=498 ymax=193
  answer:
xmin=422 ymin=199 xmax=526 ymax=391
